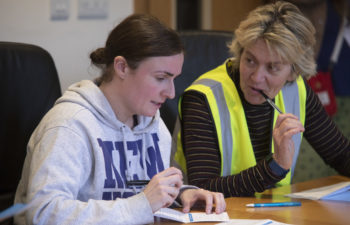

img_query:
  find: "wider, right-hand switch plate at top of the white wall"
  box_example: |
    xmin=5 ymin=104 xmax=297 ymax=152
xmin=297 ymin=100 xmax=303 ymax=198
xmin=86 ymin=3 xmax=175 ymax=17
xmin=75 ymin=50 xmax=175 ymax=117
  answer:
xmin=78 ymin=0 xmax=109 ymax=19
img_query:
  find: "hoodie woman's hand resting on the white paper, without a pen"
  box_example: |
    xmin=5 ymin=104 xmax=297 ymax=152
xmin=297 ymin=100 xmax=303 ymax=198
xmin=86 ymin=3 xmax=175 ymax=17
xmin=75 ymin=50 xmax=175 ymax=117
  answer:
xmin=180 ymin=189 xmax=226 ymax=214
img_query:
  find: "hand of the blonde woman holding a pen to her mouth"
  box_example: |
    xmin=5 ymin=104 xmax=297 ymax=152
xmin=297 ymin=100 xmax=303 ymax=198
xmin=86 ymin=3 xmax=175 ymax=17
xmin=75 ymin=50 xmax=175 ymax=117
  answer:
xmin=273 ymin=113 xmax=305 ymax=170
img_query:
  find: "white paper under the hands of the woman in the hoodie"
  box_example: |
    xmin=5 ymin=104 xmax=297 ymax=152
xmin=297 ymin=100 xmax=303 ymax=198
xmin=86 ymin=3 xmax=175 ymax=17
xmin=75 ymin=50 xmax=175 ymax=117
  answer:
xmin=154 ymin=208 xmax=230 ymax=223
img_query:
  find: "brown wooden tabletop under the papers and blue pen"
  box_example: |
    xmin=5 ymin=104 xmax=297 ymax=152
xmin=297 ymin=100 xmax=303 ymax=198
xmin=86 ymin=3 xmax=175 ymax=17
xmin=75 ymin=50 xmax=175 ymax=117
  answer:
xmin=155 ymin=176 xmax=350 ymax=225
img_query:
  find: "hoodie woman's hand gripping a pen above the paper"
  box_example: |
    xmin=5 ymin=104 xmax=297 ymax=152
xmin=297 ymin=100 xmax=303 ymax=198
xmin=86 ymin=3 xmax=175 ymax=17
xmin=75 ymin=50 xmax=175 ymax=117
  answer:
xmin=143 ymin=167 xmax=182 ymax=212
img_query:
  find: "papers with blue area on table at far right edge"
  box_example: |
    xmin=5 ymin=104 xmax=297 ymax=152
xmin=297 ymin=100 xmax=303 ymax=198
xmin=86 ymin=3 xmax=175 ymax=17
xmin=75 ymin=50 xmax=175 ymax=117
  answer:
xmin=286 ymin=182 xmax=350 ymax=202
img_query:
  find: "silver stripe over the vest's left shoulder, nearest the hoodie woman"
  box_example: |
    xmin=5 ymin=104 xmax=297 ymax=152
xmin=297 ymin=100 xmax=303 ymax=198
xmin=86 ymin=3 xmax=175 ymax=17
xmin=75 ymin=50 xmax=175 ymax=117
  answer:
xmin=194 ymin=79 xmax=233 ymax=176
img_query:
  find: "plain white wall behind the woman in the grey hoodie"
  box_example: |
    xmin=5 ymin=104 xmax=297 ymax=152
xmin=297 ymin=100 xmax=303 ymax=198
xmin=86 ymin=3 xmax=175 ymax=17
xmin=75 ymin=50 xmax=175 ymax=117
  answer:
xmin=0 ymin=0 xmax=133 ymax=91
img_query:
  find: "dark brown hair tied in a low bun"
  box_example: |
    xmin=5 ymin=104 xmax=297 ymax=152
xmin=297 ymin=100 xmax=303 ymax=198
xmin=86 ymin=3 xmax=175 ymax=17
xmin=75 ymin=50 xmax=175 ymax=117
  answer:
xmin=90 ymin=14 xmax=184 ymax=82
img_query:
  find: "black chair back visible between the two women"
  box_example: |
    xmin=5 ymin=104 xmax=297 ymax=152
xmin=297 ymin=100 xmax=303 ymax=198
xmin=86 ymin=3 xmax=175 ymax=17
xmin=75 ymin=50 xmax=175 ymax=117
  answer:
xmin=160 ymin=30 xmax=233 ymax=133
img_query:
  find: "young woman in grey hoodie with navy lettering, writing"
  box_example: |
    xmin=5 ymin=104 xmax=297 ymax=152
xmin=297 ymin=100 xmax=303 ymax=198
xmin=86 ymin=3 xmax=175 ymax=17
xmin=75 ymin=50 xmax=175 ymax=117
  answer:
xmin=15 ymin=15 xmax=226 ymax=224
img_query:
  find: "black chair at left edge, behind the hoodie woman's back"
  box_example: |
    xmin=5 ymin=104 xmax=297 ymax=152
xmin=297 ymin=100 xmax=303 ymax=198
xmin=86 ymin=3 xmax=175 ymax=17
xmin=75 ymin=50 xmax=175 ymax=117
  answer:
xmin=0 ymin=42 xmax=61 ymax=224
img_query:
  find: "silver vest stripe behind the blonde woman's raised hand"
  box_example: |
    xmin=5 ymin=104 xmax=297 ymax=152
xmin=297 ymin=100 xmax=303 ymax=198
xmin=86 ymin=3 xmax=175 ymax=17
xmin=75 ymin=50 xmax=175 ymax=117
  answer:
xmin=282 ymin=81 xmax=301 ymax=177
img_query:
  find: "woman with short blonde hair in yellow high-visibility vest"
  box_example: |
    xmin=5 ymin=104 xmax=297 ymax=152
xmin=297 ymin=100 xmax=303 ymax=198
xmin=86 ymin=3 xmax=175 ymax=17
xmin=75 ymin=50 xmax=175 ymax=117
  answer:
xmin=175 ymin=2 xmax=350 ymax=197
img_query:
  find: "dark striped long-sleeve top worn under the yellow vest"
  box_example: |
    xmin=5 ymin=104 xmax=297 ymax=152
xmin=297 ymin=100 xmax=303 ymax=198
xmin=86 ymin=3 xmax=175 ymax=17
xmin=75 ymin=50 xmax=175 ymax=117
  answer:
xmin=181 ymin=62 xmax=350 ymax=197
